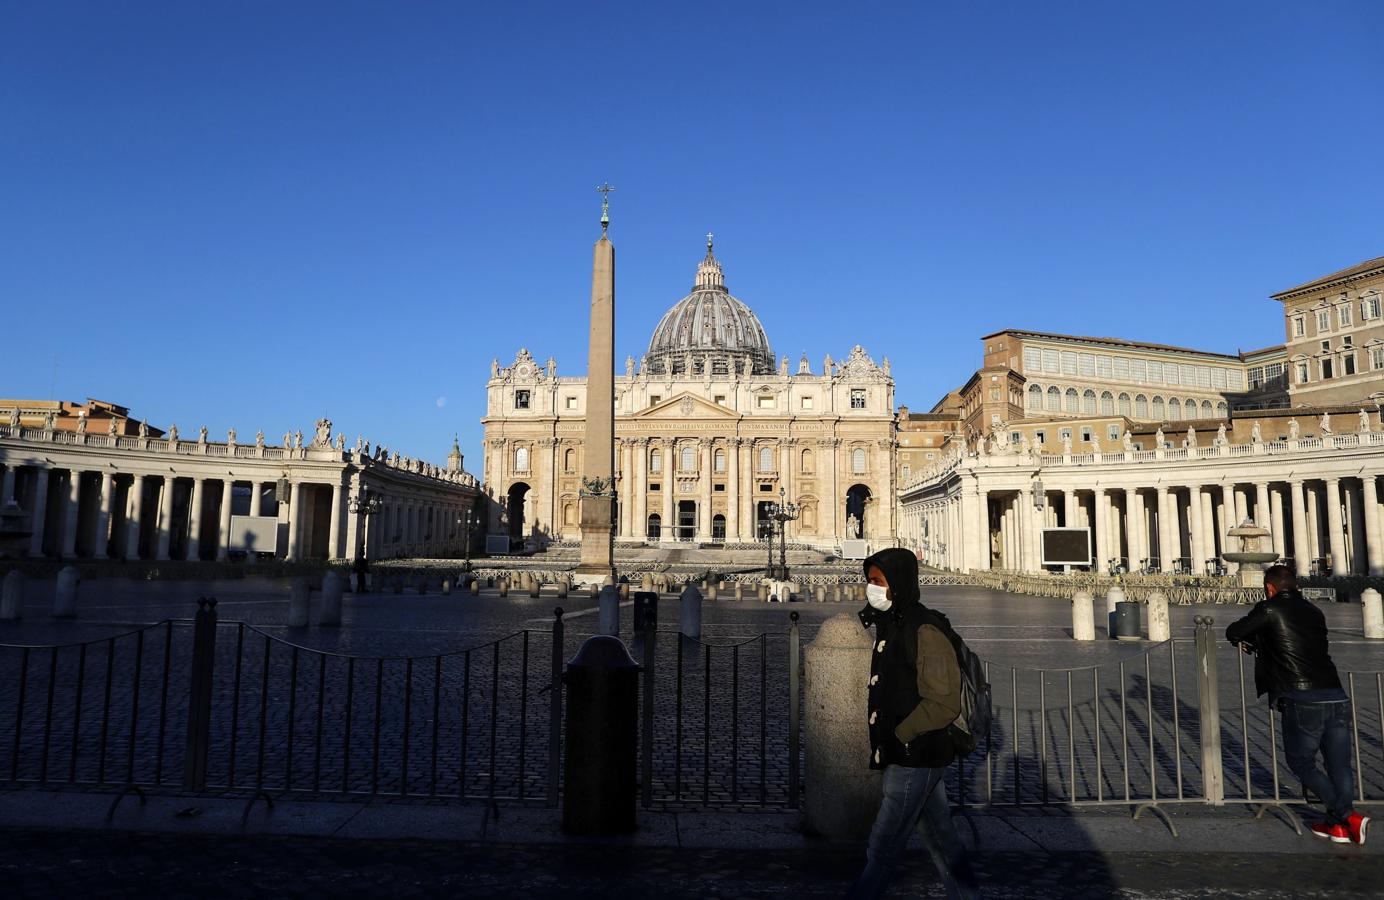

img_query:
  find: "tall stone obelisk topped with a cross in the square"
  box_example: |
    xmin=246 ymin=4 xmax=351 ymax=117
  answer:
xmin=573 ymin=184 xmax=614 ymax=584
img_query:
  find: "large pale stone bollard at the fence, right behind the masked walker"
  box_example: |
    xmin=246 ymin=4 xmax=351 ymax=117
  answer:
xmin=803 ymin=613 xmax=880 ymax=840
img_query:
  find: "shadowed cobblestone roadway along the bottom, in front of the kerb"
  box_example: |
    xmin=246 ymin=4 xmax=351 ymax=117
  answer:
xmin=0 ymin=831 xmax=1384 ymax=900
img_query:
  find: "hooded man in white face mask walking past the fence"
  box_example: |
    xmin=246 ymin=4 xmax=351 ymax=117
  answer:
xmin=850 ymin=547 xmax=980 ymax=900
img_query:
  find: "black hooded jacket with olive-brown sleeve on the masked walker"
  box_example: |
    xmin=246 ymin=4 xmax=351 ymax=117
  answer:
xmin=859 ymin=547 xmax=960 ymax=768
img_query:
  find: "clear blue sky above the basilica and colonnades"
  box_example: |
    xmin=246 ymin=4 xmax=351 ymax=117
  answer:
xmin=0 ymin=0 xmax=1384 ymax=471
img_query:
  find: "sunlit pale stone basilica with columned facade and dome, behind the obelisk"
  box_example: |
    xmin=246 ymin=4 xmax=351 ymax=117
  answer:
xmin=482 ymin=237 xmax=897 ymax=551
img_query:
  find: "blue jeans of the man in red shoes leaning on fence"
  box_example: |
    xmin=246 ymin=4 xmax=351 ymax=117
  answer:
xmin=1279 ymin=698 xmax=1355 ymax=825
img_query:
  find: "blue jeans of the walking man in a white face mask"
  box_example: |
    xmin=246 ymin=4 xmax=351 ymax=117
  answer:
xmin=848 ymin=766 xmax=980 ymax=900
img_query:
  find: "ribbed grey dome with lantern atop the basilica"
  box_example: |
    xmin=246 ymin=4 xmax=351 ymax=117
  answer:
xmin=645 ymin=235 xmax=774 ymax=375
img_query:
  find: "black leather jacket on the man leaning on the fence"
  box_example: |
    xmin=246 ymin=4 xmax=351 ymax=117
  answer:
xmin=1225 ymin=591 xmax=1341 ymax=694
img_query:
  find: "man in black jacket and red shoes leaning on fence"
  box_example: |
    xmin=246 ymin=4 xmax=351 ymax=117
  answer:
xmin=1225 ymin=565 xmax=1370 ymax=843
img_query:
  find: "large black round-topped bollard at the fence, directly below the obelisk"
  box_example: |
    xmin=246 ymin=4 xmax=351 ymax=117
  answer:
xmin=562 ymin=634 xmax=639 ymax=836
